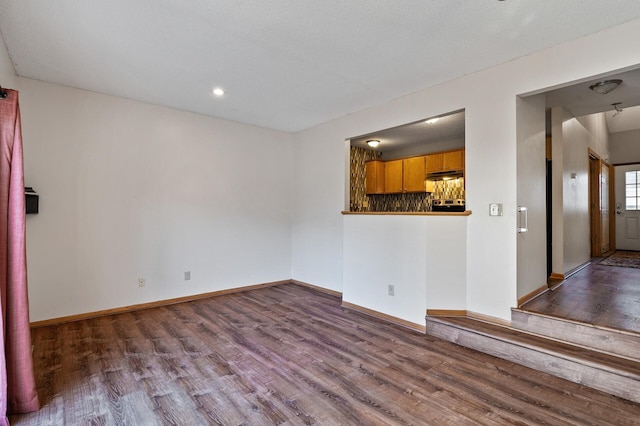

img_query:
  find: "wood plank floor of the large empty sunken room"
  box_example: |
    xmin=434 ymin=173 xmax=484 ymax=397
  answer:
xmin=10 ymin=284 xmax=640 ymax=426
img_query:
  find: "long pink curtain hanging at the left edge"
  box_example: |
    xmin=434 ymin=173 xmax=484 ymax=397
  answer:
xmin=0 ymin=90 xmax=40 ymax=426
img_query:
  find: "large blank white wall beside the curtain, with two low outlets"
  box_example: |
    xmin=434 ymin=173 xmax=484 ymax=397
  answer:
xmin=18 ymin=78 xmax=296 ymax=321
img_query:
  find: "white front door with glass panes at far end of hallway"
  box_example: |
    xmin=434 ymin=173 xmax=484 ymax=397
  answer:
xmin=615 ymin=164 xmax=640 ymax=251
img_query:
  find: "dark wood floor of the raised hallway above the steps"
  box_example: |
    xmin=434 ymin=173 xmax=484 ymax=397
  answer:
xmin=522 ymin=259 xmax=640 ymax=333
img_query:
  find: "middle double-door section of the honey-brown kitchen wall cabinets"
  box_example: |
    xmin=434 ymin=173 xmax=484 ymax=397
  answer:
xmin=384 ymin=156 xmax=426 ymax=194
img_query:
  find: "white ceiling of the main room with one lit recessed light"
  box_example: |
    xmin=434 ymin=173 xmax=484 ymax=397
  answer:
xmin=0 ymin=0 xmax=640 ymax=131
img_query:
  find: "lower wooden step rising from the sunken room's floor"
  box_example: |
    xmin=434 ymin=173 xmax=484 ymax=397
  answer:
xmin=426 ymin=316 xmax=640 ymax=402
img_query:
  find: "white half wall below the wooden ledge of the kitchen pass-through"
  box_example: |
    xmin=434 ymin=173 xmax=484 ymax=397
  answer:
xmin=343 ymin=215 xmax=467 ymax=325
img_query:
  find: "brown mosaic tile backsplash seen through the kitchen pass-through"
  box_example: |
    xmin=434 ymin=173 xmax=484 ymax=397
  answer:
xmin=349 ymin=146 xmax=464 ymax=212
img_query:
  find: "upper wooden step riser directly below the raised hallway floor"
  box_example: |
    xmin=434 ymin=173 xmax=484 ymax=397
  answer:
xmin=511 ymin=308 xmax=640 ymax=362
